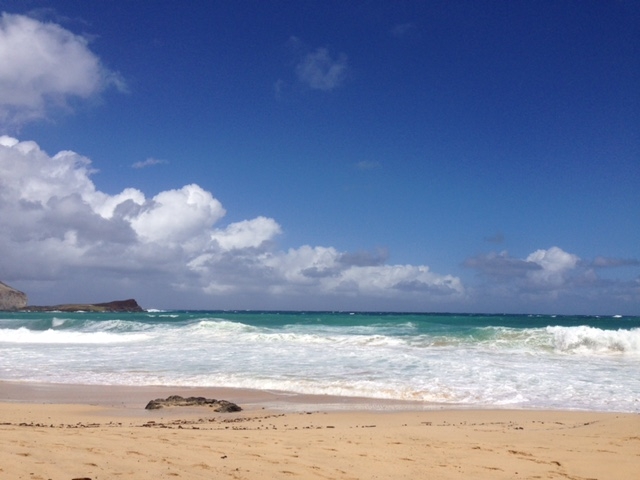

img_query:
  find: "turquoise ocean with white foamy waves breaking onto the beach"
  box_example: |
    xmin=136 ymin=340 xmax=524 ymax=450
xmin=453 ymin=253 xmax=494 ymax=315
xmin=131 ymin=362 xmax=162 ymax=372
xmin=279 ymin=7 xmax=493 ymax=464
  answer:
xmin=0 ymin=311 xmax=640 ymax=412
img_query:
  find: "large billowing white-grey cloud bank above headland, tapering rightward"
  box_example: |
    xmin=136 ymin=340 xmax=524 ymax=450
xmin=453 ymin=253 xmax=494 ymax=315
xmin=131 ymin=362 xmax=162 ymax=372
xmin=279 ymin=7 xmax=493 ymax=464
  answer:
xmin=0 ymin=136 xmax=464 ymax=306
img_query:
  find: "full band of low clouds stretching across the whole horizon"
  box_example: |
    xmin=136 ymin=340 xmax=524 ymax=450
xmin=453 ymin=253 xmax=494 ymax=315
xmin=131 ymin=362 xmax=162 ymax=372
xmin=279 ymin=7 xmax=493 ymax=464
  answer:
xmin=0 ymin=135 xmax=640 ymax=310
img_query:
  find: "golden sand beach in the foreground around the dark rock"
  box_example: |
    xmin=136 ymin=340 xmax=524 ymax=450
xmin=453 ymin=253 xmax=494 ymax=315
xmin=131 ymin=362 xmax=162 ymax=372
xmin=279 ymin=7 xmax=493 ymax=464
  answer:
xmin=0 ymin=382 xmax=640 ymax=480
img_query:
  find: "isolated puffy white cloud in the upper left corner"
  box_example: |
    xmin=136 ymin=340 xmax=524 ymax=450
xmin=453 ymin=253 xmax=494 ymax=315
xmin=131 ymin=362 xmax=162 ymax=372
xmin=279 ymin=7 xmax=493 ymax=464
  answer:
xmin=0 ymin=13 xmax=126 ymax=125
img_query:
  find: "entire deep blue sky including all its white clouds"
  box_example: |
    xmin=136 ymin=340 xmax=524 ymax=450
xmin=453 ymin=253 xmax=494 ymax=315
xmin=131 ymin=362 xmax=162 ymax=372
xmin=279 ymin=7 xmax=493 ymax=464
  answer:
xmin=0 ymin=0 xmax=640 ymax=314
